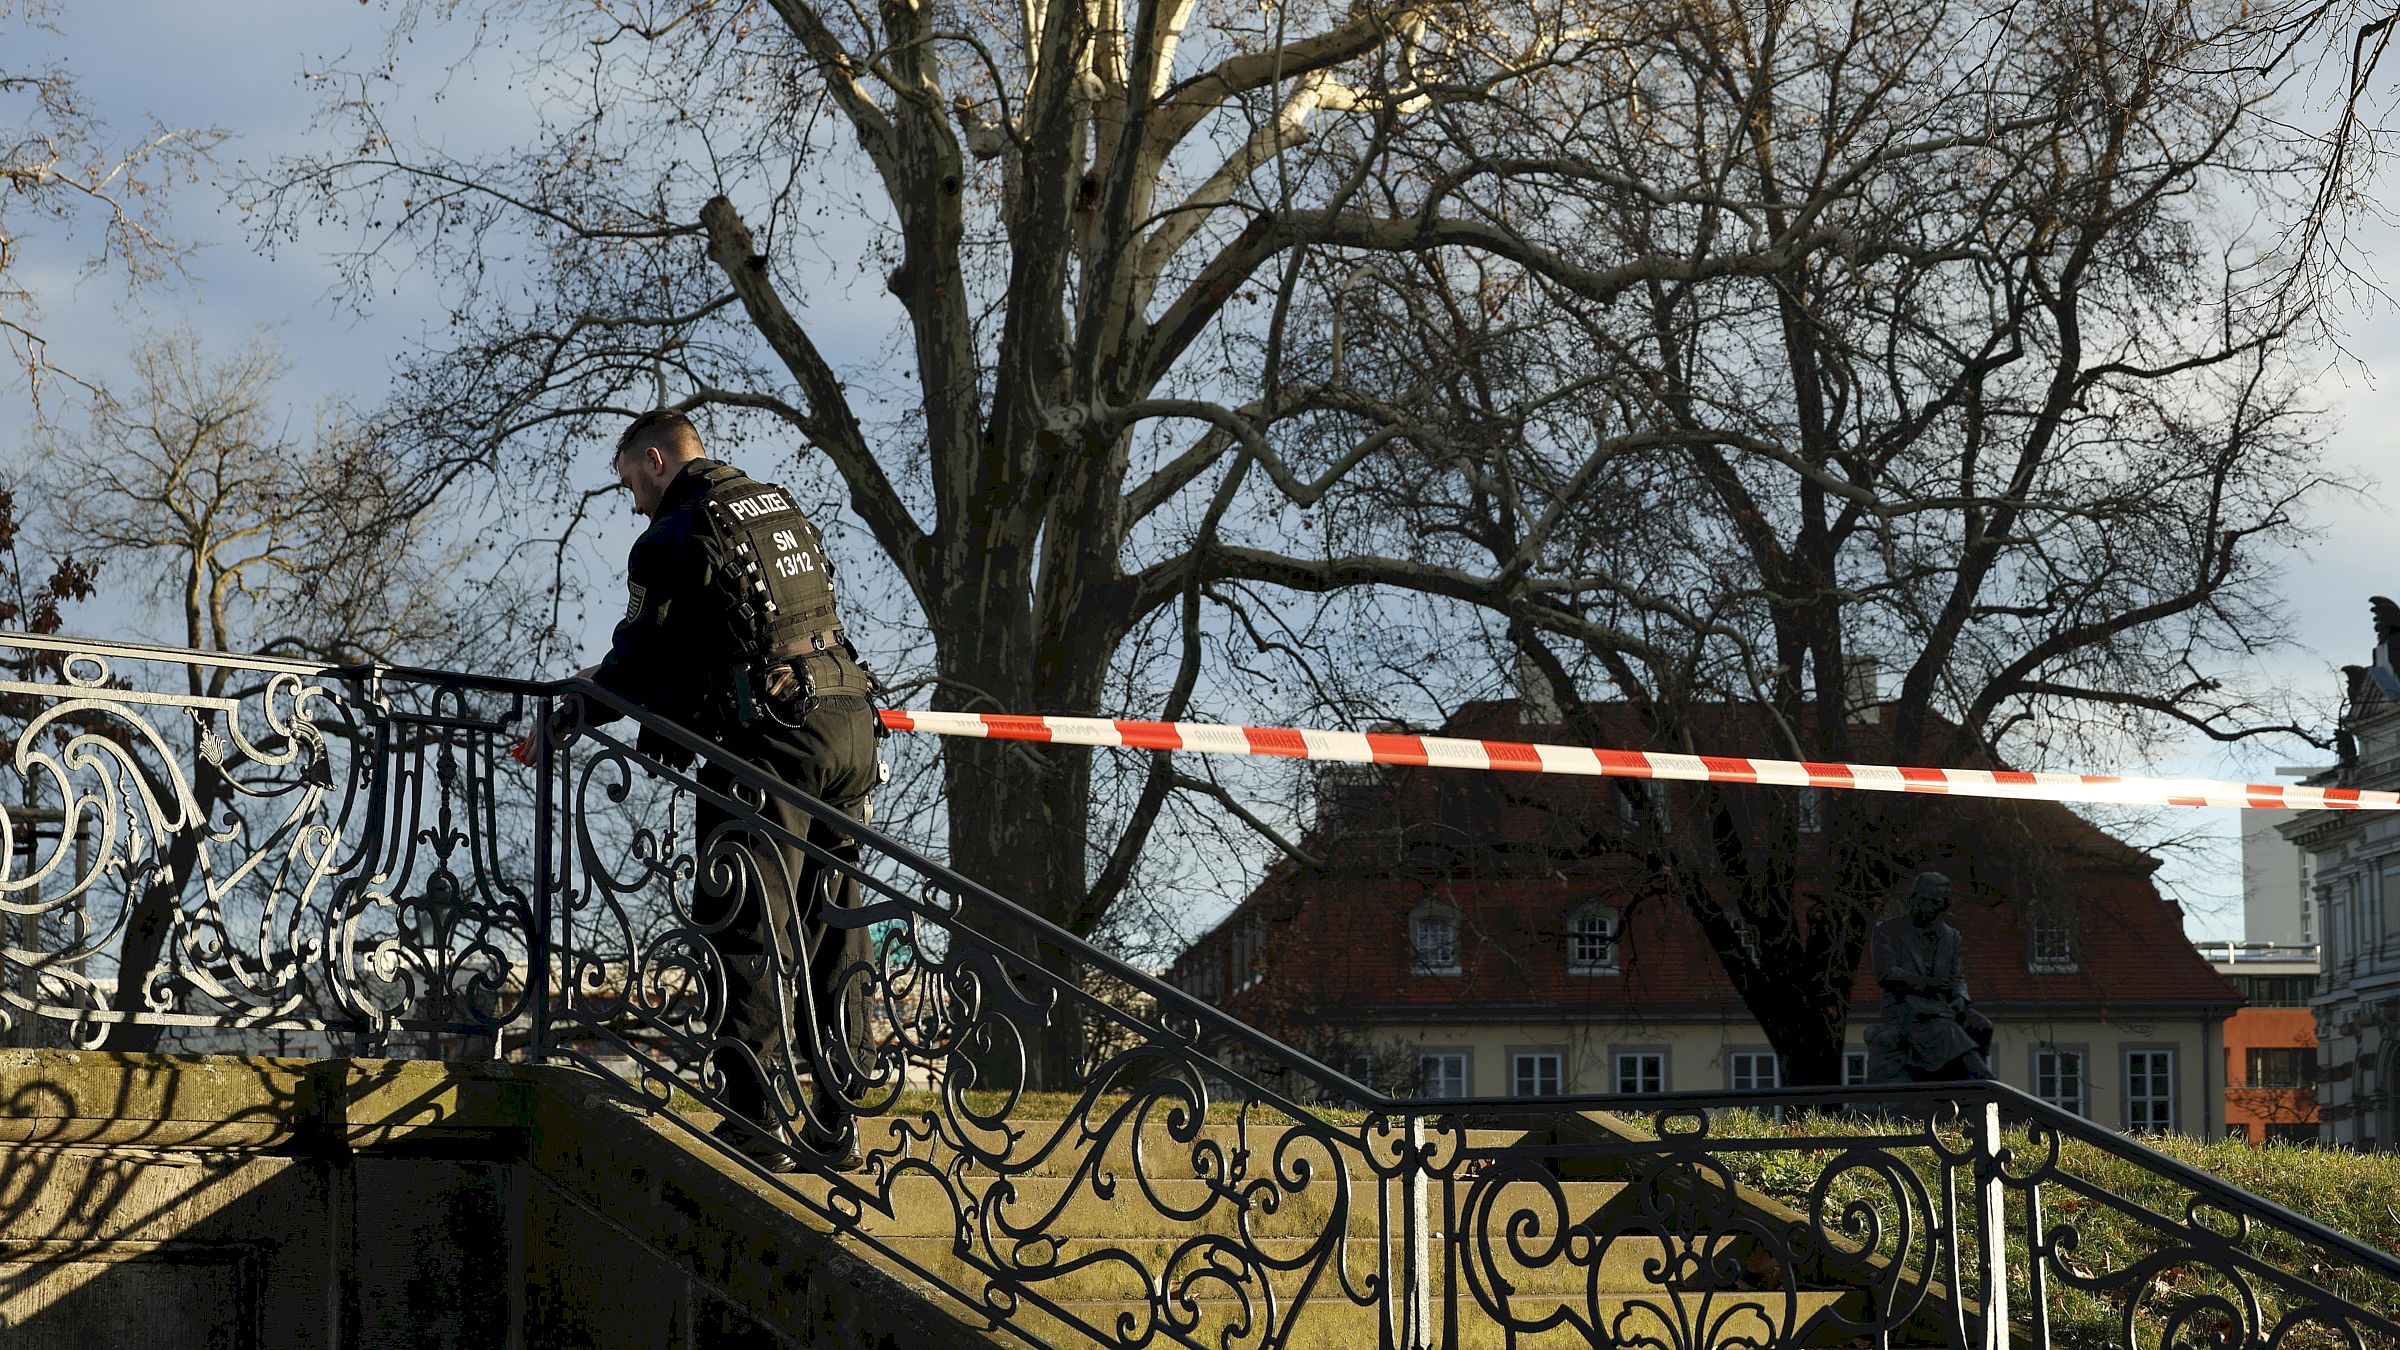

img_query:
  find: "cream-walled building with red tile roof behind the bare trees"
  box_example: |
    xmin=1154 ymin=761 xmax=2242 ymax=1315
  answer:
xmin=1169 ymin=704 xmax=2242 ymax=1134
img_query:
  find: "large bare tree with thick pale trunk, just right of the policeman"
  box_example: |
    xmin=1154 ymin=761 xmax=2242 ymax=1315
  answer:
xmin=250 ymin=0 xmax=2009 ymax=1062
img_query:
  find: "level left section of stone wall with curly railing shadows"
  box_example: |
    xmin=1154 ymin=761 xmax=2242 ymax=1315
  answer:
xmin=0 ymin=1052 xmax=526 ymax=1350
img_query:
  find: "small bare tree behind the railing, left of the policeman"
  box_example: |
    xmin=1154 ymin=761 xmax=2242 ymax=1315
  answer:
xmin=43 ymin=334 xmax=530 ymax=1050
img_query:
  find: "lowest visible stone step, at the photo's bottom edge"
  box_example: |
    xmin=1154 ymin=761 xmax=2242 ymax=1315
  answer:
xmin=1013 ymin=1290 xmax=1853 ymax=1350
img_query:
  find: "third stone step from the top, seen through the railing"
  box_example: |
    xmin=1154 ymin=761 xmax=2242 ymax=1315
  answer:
xmin=876 ymin=1235 xmax=1706 ymax=1300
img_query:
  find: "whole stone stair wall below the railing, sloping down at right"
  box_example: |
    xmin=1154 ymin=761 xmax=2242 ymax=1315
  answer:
xmin=0 ymin=1050 xmax=984 ymax=1350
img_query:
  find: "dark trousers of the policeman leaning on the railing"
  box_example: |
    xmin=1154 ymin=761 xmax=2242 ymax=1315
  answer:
xmin=691 ymin=697 xmax=876 ymax=1136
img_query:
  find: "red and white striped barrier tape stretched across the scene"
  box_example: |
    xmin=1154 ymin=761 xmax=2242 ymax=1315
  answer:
xmin=883 ymin=709 xmax=2400 ymax=812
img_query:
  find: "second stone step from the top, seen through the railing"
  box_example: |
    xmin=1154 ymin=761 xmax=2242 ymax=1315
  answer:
xmin=794 ymin=1170 xmax=1625 ymax=1240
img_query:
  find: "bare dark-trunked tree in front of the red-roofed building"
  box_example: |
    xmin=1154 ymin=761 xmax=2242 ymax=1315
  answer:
xmin=1276 ymin=0 xmax=2326 ymax=1081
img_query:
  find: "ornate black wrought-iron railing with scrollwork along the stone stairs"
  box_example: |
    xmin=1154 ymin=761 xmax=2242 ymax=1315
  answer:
xmin=0 ymin=634 xmax=2400 ymax=1350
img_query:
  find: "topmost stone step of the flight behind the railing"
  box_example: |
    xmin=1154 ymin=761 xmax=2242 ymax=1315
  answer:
xmin=859 ymin=1115 xmax=1524 ymax=1179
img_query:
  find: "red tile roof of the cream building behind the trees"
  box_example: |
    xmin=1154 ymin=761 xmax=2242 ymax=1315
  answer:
xmin=1174 ymin=704 xmax=2239 ymax=1021
